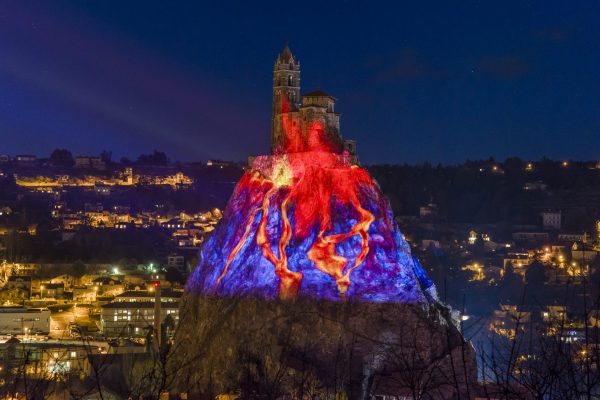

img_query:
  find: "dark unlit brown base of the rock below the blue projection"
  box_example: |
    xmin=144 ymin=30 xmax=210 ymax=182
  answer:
xmin=169 ymin=294 xmax=476 ymax=399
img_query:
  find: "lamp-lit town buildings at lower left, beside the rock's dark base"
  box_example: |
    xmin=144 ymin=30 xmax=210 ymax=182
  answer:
xmin=0 ymin=256 xmax=183 ymax=390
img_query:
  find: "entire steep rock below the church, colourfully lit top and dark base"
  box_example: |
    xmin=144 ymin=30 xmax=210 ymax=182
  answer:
xmin=176 ymin=99 xmax=475 ymax=399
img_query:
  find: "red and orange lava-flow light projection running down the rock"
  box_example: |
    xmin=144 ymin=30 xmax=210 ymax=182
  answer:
xmin=215 ymin=99 xmax=374 ymax=298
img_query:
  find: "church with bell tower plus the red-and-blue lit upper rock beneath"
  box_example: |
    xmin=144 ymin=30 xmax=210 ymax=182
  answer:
xmin=187 ymin=46 xmax=436 ymax=303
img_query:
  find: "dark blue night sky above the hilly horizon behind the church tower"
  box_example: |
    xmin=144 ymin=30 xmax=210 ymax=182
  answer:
xmin=0 ymin=0 xmax=600 ymax=163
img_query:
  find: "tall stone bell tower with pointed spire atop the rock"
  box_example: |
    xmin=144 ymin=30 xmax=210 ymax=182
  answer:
xmin=271 ymin=43 xmax=300 ymax=152
